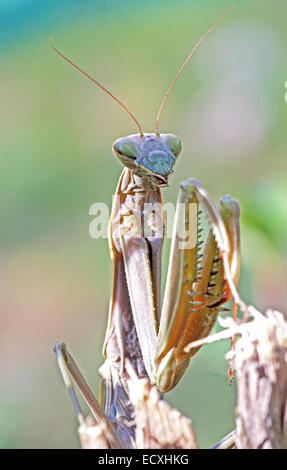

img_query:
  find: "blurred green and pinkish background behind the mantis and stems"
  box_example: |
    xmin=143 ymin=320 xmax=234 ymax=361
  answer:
xmin=0 ymin=0 xmax=287 ymax=448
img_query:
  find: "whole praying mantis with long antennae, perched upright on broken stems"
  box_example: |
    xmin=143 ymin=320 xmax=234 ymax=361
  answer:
xmin=51 ymin=7 xmax=248 ymax=447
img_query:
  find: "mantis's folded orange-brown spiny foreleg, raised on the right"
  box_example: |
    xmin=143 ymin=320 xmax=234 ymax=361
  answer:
xmin=156 ymin=178 xmax=240 ymax=392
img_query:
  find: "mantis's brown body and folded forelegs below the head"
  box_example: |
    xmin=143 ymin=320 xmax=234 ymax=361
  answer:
xmin=100 ymin=169 xmax=239 ymax=446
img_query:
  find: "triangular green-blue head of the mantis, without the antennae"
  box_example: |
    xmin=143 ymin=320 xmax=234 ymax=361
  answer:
xmin=113 ymin=134 xmax=181 ymax=186
